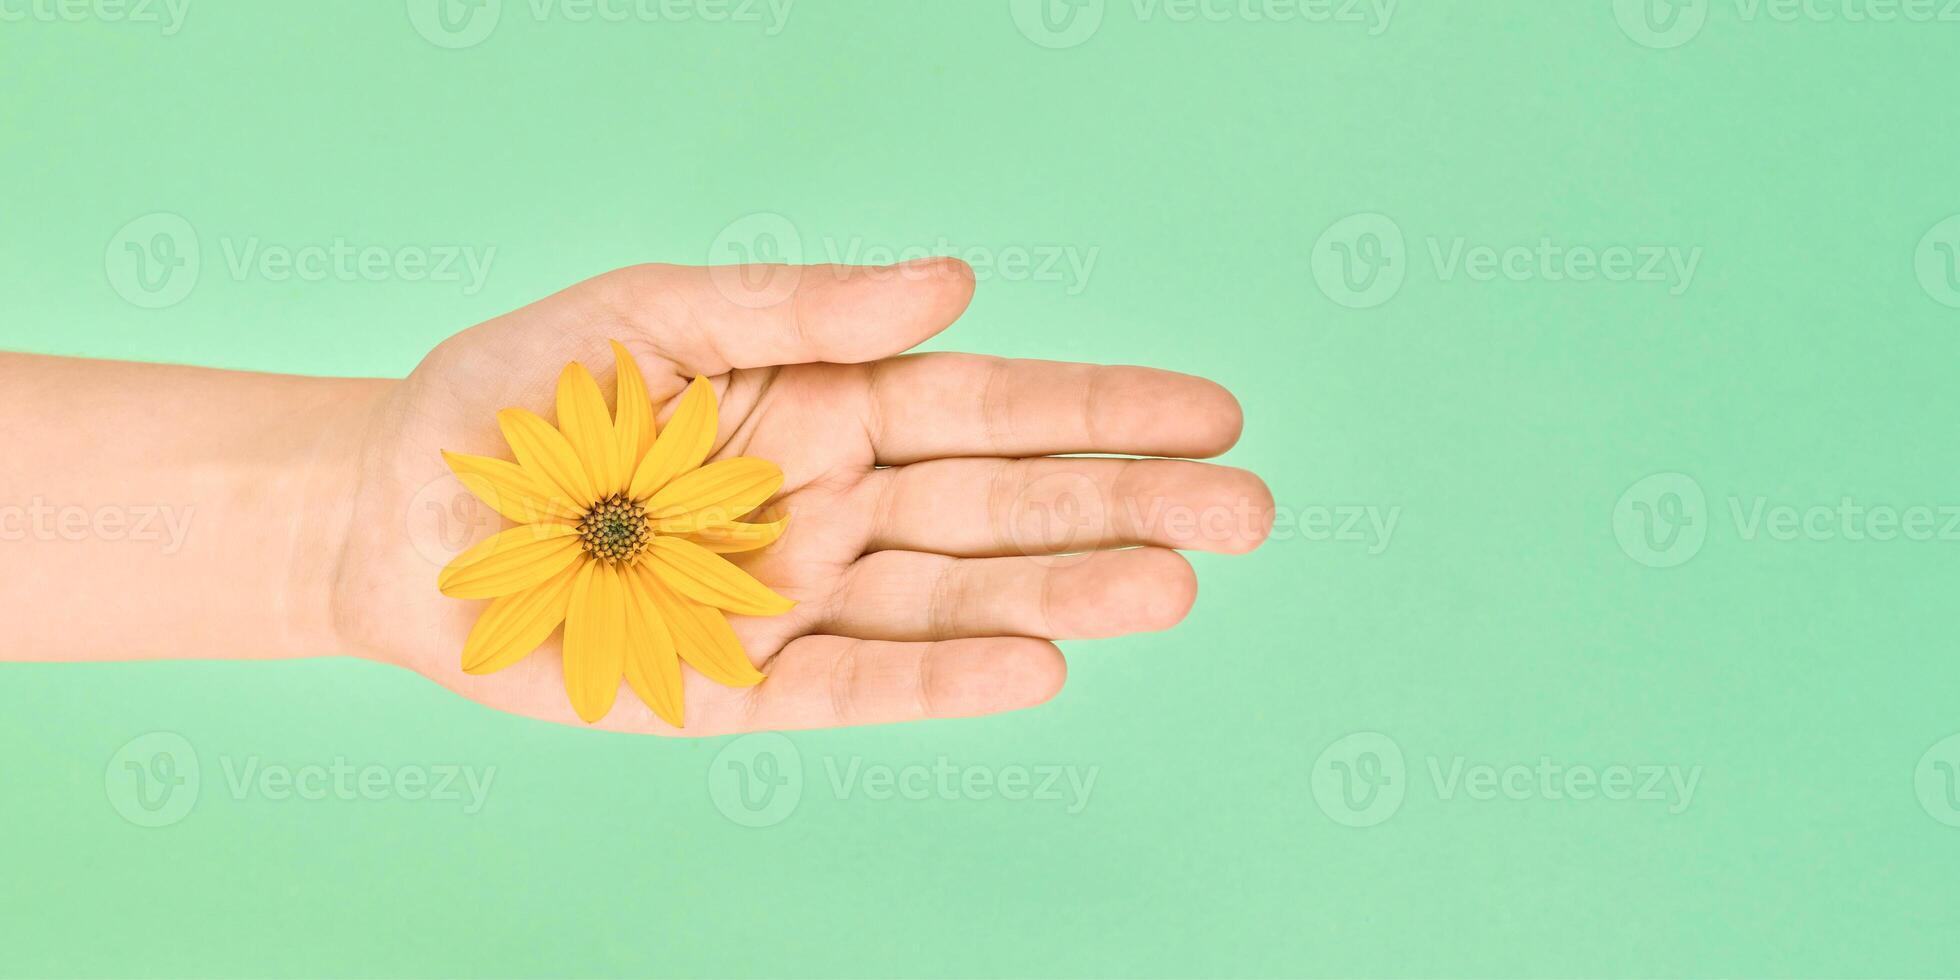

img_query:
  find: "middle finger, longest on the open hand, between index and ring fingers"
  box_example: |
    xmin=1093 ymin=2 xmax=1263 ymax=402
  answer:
xmin=866 ymin=459 xmax=1272 ymax=557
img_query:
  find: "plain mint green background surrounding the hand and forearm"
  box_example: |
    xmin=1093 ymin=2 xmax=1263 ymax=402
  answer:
xmin=0 ymin=0 xmax=1960 ymax=976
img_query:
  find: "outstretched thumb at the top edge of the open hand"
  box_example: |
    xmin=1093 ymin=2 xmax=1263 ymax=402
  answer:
xmin=594 ymin=259 xmax=974 ymax=374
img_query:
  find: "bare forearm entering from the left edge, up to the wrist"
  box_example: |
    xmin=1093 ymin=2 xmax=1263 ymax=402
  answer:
xmin=0 ymin=353 xmax=392 ymax=661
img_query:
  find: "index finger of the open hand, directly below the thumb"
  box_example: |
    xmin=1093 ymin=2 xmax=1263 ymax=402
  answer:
xmin=866 ymin=353 xmax=1243 ymax=465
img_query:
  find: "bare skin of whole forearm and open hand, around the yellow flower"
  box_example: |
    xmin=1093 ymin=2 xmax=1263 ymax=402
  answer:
xmin=0 ymin=259 xmax=1272 ymax=735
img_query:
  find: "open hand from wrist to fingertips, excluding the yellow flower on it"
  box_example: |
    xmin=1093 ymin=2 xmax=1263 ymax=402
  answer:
xmin=331 ymin=259 xmax=1272 ymax=735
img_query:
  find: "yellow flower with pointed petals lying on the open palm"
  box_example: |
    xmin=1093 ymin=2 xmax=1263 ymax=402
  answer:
xmin=437 ymin=341 xmax=796 ymax=727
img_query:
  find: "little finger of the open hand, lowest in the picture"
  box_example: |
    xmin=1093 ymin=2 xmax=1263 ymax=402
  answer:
xmin=736 ymin=637 xmax=1068 ymax=735
